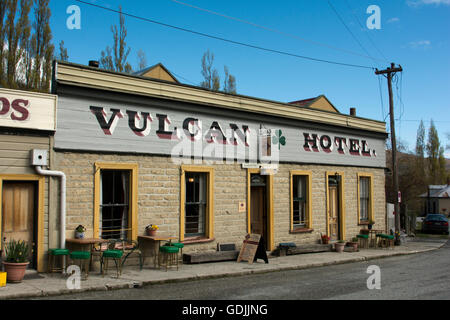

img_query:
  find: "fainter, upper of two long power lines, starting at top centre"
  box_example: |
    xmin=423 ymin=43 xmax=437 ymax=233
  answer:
xmin=170 ymin=0 xmax=382 ymax=61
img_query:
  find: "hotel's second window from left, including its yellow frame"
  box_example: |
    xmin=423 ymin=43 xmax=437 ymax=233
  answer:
xmin=180 ymin=166 xmax=214 ymax=241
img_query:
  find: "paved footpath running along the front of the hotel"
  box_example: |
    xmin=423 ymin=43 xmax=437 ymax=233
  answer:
xmin=0 ymin=239 xmax=448 ymax=300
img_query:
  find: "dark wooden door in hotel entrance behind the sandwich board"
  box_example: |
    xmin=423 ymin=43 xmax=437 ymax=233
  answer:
xmin=250 ymin=187 xmax=266 ymax=239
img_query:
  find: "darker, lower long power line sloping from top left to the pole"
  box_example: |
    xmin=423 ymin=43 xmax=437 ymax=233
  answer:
xmin=75 ymin=0 xmax=375 ymax=70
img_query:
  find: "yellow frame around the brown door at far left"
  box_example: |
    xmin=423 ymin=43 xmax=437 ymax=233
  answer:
xmin=0 ymin=174 xmax=45 ymax=272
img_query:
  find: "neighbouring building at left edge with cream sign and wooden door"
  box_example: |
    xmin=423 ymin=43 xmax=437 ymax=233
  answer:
xmin=0 ymin=88 xmax=59 ymax=271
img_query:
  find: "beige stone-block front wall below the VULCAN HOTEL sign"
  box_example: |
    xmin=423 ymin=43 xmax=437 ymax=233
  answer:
xmin=52 ymin=152 xmax=385 ymax=258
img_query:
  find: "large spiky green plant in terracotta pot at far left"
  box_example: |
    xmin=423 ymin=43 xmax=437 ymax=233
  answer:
xmin=2 ymin=240 xmax=30 ymax=283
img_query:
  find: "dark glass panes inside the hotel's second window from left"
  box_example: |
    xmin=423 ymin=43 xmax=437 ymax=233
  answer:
xmin=184 ymin=172 xmax=207 ymax=237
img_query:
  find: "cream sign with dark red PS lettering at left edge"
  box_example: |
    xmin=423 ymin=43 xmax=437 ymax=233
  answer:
xmin=0 ymin=89 xmax=56 ymax=131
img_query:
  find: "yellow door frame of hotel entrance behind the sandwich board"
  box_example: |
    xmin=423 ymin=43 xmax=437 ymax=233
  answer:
xmin=247 ymin=168 xmax=275 ymax=251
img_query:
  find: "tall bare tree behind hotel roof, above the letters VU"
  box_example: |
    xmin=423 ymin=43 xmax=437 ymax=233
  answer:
xmin=100 ymin=7 xmax=133 ymax=73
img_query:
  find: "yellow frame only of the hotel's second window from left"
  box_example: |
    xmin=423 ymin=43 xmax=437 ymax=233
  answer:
xmin=180 ymin=165 xmax=214 ymax=241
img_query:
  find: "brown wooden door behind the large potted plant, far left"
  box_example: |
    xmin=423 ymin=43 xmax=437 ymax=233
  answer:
xmin=2 ymin=182 xmax=35 ymax=261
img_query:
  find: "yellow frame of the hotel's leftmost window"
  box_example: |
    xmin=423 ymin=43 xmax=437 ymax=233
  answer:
xmin=93 ymin=162 xmax=139 ymax=240
